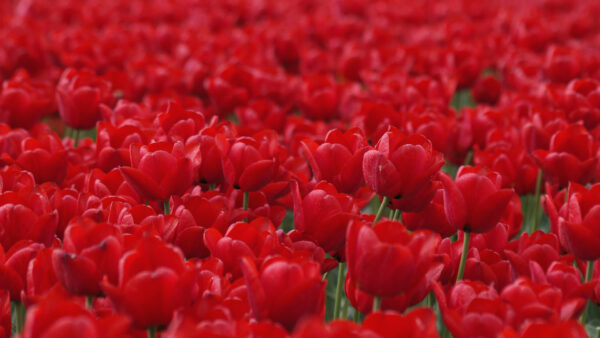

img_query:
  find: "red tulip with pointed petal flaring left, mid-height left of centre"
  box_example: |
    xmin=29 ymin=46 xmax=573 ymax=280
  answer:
xmin=120 ymin=142 xmax=194 ymax=201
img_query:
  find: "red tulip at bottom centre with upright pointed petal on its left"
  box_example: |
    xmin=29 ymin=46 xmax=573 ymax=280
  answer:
xmin=241 ymin=256 xmax=327 ymax=330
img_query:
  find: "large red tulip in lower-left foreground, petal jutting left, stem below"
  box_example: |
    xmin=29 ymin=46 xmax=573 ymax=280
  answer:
xmin=101 ymin=237 xmax=195 ymax=329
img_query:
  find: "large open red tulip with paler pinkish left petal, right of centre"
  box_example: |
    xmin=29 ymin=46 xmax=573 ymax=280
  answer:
xmin=363 ymin=130 xmax=444 ymax=211
